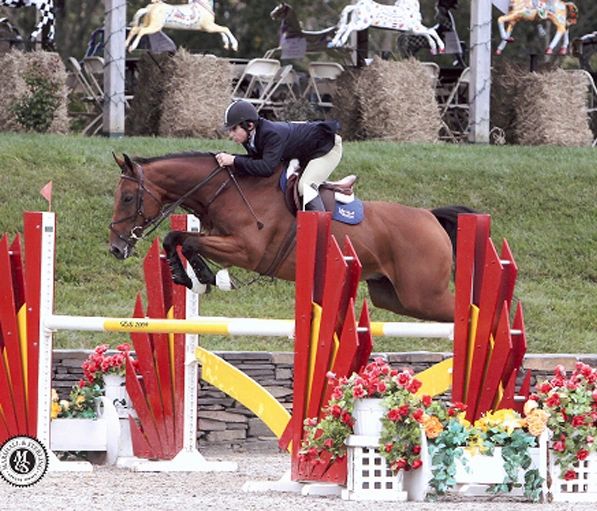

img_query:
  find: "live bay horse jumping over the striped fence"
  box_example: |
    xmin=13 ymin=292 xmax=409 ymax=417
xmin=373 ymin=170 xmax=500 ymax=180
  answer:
xmin=109 ymin=153 xmax=472 ymax=322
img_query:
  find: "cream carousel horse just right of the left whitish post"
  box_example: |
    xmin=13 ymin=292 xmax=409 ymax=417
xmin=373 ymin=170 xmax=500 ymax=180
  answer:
xmin=126 ymin=0 xmax=238 ymax=51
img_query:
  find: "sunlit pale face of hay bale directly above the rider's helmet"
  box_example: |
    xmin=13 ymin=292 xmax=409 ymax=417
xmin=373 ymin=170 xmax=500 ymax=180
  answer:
xmin=159 ymin=51 xmax=232 ymax=138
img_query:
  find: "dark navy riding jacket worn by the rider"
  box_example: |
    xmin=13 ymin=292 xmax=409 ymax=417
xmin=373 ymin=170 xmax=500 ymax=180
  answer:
xmin=234 ymin=117 xmax=338 ymax=177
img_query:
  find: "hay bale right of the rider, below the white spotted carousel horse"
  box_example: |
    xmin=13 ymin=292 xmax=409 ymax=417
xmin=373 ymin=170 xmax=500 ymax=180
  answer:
xmin=334 ymin=58 xmax=441 ymax=142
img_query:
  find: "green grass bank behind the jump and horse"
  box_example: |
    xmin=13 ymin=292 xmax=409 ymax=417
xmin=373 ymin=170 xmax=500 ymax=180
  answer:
xmin=0 ymin=134 xmax=597 ymax=353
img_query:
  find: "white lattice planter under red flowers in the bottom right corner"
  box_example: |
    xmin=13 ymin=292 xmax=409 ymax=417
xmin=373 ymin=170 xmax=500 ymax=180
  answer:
xmin=548 ymin=453 xmax=597 ymax=502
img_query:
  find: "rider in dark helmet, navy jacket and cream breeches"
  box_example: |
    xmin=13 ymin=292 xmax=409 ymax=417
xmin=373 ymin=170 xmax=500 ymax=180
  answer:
xmin=216 ymin=100 xmax=342 ymax=211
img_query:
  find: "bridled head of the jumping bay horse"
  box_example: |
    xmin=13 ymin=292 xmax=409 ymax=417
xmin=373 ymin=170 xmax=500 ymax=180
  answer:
xmin=110 ymin=154 xmax=162 ymax=259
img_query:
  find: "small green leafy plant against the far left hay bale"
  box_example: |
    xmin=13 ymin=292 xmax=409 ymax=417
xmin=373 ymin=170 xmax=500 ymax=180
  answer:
xmin=12 ymin=73 xmax=60 ymax=133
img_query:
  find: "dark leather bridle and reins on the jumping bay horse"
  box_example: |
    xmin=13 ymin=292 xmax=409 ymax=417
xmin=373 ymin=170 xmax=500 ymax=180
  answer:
xmin=109 ymin=159 xmax=263 ymax=248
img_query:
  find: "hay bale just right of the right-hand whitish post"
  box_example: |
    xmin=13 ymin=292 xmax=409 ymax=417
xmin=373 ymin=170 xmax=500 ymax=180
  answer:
xmin=502 ymin=69 xmax=592 ymax=147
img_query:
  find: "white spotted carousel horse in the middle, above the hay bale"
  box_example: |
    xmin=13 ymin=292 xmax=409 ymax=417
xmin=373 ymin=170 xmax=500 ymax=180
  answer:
xmin=329 ymin=0 xmax=444 ymax=55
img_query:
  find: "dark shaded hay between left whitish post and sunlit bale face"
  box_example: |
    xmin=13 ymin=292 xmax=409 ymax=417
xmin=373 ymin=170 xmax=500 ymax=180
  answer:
xmin=126 ymin=53 xmax=174 ymax=136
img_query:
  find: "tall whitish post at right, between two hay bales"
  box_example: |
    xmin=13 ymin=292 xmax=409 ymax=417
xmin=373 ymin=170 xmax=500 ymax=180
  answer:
xmin=469 ymin=0 xmax=492 ymax=144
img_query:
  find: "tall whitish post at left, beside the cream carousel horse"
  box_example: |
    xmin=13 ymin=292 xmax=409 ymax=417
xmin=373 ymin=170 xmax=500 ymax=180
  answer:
xmin=103 ymin=0 xmax=126 ymax=138
